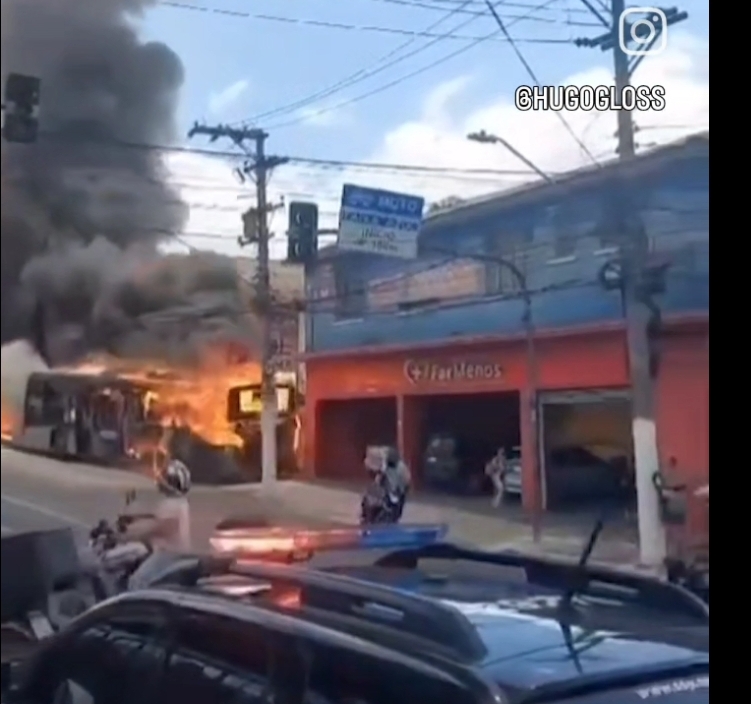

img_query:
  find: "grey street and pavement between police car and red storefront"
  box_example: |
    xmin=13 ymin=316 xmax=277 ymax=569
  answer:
xmin=0 ymin=447 xmax=648 ymax=566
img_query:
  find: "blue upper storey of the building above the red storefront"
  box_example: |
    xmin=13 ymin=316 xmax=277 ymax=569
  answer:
xmin=307 ymin=134 xmax=709 ymax=353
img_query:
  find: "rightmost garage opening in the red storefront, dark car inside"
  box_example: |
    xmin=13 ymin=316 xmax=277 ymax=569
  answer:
xmin=541 ymin=391 xmax=636 ymax=512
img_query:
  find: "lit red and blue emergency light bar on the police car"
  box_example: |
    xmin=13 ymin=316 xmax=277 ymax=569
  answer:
xmin=209 ymin=524 xmax=448 ymax=560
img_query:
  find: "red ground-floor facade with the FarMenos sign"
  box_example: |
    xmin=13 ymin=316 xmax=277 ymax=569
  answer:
xmin=303 ymin=317 xmax=709 ymax=506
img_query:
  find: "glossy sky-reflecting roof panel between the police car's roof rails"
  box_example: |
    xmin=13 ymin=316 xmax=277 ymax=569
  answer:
xmin=324 ymin=564 xmax=708 ymax=689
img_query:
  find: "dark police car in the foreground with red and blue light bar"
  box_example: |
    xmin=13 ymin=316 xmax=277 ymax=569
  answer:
xmin=4 ymin=525 xmax=709 ymax=704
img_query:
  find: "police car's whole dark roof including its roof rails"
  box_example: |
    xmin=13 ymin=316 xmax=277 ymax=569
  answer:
xmin=103 ymin=544 xmax=709 ymax=691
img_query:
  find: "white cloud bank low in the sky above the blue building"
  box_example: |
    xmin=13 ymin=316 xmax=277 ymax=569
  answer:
xmin=170 ymin=33 xmax=709 ymax=256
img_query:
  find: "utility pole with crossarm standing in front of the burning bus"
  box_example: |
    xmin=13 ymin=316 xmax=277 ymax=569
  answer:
xmin=188 ymin=124 xmax=287 ymax=491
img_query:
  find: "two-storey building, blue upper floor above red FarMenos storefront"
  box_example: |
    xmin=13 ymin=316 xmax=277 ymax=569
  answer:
xmin=303 ymin=134 xmax=709 ymax=506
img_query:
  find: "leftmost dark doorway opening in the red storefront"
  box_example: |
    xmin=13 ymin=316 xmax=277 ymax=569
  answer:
xmin=316 ymin=397 xmax=397 ymax=481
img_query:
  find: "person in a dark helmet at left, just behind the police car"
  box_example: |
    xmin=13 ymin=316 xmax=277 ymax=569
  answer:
xmin=120 ymin=459 xmax=191 ymax=589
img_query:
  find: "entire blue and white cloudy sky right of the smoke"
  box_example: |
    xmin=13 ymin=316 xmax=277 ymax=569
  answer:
xmin=139 ymin=0 xmax=709 ymax=256
